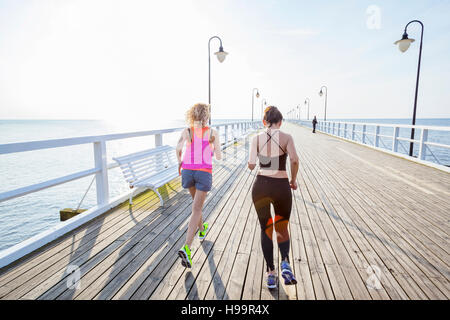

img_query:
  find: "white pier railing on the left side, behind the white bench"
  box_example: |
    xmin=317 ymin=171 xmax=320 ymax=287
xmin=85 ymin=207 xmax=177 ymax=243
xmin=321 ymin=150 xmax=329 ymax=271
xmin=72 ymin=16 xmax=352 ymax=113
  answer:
xmin=0 ymin=121 xmax=261 ymax=268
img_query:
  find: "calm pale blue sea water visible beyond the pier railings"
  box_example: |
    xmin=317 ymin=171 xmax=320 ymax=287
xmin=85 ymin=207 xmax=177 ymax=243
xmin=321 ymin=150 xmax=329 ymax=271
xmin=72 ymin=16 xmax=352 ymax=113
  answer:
xmin=0 ymin=119 xmax=450 ymax=251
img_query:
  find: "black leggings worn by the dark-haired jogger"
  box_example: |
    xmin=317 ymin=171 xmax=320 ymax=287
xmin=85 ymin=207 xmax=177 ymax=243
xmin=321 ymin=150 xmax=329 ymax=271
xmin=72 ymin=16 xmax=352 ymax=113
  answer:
xmin=252 ymin=175 xmax=292 ymax=271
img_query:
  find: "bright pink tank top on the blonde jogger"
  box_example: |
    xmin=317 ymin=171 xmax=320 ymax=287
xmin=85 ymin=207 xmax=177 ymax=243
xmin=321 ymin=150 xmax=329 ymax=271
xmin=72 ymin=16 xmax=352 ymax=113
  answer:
xmin=181 ymin=127 xmax=213 ymax=172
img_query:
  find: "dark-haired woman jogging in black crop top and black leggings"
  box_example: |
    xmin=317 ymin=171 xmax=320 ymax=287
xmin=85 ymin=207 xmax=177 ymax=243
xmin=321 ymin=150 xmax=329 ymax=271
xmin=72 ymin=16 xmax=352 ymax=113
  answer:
xmin=248 ymin=106 xmax=299 ymax=288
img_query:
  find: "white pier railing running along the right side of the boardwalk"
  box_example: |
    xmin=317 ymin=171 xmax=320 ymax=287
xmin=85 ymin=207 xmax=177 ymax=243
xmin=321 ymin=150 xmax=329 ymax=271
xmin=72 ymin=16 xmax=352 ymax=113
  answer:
xmin=291 ymin=120 xmax=450 ymax=171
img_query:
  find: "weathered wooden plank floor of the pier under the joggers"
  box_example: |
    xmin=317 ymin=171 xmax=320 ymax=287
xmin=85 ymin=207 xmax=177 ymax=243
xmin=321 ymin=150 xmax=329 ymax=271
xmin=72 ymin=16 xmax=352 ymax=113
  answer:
xmin=0 ymin=123 xmax=450 ymax=300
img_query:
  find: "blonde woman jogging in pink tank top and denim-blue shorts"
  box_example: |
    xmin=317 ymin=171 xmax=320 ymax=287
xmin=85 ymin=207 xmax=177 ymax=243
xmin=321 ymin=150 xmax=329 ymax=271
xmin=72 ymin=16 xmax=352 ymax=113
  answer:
xmin=176 ymin=103 xmax=222 ymax=268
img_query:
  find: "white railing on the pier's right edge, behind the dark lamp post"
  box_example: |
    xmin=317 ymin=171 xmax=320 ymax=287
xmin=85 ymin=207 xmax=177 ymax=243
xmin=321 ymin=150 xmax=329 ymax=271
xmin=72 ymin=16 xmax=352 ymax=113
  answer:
xmin=290 ymin=120 xmax=450 ymax=171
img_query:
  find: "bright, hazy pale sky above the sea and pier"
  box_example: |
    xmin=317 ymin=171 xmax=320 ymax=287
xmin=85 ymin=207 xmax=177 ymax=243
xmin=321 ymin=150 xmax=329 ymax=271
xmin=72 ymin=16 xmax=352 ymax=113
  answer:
xmin=0 ymin=0 xmax=450 ymax=123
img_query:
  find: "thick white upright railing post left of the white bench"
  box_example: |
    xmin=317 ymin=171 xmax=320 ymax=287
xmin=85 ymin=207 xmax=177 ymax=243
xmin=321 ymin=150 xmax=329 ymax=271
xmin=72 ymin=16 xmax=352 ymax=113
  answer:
xmin=94 ymin=141 xmax=109 ymax=205
